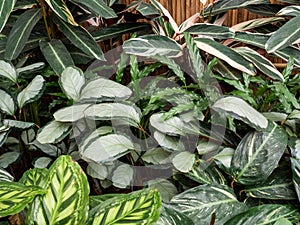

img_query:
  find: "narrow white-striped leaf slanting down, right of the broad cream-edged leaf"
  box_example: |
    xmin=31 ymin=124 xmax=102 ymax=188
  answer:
xmin=234 ymin=47 xmax=284 ymax=81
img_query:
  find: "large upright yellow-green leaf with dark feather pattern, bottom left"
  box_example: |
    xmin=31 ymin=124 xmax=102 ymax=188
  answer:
xmin=26 ymin=156 xmax=89 ymax=225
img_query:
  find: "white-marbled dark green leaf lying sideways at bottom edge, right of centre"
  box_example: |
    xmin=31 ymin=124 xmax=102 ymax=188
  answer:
xmin=170 ymin=184 xmax=245 ymax=225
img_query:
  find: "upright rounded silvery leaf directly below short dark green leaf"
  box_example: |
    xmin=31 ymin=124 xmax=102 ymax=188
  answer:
xmin=59 ymin=67 xmax=85 ymax=101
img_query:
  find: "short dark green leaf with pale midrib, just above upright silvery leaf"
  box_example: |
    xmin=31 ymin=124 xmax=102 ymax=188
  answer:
xmin=40 ymin=39 xmax=74 ymax=75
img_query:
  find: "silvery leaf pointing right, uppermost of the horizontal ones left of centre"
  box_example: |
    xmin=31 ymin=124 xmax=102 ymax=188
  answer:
xmin=80 ymin=78 xmax=132 ymax=102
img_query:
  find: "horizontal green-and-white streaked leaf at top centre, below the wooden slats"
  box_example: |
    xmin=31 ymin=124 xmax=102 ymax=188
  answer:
xmin=123 ymin=35 xmax=181 ymax=57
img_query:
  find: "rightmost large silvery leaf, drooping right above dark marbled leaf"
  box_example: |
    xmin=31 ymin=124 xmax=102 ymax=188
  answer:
xmin=212 ymin=96 xmax=268 ymax=130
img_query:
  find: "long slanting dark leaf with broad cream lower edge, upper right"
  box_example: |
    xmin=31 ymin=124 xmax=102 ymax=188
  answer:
xmin=194 ymin=38 xmax=256 ymax=75
